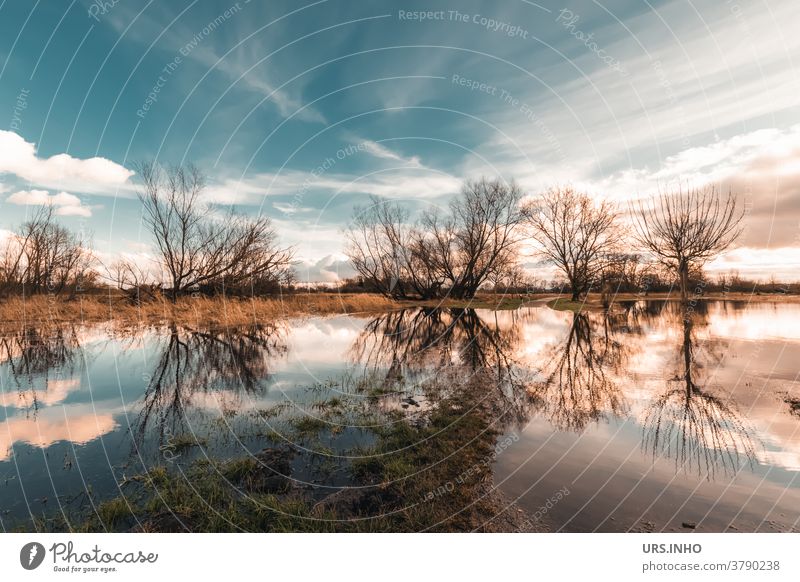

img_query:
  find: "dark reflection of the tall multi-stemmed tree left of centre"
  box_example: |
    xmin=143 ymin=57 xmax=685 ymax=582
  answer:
xmin=136 ymin=325 xmax=287 ymax=445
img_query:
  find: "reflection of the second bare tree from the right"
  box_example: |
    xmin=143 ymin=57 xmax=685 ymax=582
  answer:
xmin=532 ymin=312 xmax=631 ymax=431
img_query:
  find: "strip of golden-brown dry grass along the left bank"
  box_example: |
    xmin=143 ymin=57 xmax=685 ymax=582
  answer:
xmin=0 ymin=293 xmax=399 ymax=325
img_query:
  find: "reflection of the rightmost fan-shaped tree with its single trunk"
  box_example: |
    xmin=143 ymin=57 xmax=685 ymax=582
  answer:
xmin=642 ymin=303 xmax=755 ymax=479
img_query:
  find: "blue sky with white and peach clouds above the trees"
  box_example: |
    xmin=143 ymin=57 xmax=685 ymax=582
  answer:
xmin=0 ymin=0 xmax=800 ymax=282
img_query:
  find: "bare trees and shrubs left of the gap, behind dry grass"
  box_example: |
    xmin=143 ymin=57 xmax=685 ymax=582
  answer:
xmin=0 ymin=162 xmax=293 ymax=301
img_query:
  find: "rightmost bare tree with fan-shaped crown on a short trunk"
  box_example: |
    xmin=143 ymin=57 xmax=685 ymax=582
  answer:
xmin=634 ymin=186 xmax=744 ymax=302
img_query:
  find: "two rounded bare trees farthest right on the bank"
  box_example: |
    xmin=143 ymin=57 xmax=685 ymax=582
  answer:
xmin=526 ymin=186 xmax=744 ymax=300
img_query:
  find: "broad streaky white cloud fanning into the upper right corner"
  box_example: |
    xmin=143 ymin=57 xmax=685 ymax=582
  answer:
xmin=479 ymin=0 xmax=800 ymax=187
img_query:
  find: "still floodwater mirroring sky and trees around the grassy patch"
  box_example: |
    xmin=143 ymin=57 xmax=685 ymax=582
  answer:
xmin=0 ymin=301 xmax=800 ymax=531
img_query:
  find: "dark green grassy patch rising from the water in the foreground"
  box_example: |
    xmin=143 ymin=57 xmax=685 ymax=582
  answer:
xmin=29 ymin=374 xmax=532 ymax=532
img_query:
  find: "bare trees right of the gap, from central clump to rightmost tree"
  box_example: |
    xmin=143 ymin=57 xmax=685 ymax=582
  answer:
xmin=346 ymin=179 xmax=744 ymax=300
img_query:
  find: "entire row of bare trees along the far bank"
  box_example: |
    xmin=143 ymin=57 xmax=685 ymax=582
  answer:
xmin=0 ymin=162 xmax=743 ymax=300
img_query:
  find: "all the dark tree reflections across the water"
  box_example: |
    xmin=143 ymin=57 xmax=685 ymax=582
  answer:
xmin=0 ymin=301 xmax=755 ymax=477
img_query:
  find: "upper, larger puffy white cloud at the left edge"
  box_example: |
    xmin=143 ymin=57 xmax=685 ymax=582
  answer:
xmin=0 ymin=130 xmax=133 ymax=194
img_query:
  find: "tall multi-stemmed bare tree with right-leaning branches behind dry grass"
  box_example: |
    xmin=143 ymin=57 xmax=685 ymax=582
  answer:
xmin=137 ymin=162 xmax=293 ymax=301
